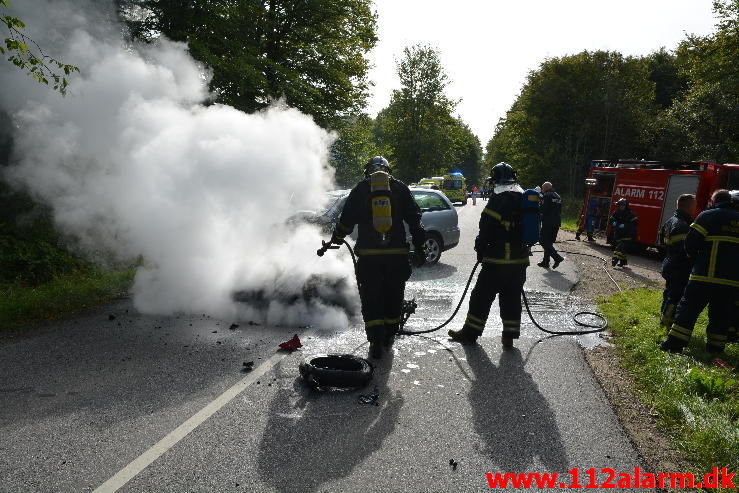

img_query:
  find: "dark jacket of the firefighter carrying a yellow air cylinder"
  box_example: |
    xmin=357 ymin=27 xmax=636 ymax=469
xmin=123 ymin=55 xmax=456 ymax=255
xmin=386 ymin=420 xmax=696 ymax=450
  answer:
xmin=334 ymin=177 xmax=426 ymax=257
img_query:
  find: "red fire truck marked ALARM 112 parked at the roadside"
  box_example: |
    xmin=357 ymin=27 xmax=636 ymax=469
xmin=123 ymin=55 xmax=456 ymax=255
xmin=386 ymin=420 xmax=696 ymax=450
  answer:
xmin=579 ymin=160 xmax=739 ymax=248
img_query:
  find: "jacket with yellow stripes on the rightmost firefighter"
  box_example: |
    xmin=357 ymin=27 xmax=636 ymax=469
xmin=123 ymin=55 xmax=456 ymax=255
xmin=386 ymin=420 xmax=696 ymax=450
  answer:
xmin=685 ymin=204 xmax=739 ymax=288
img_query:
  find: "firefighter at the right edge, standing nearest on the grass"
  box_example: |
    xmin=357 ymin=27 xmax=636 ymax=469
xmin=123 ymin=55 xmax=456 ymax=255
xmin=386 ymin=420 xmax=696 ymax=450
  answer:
xmin=662 ymin=190 xmax=739 ymax=353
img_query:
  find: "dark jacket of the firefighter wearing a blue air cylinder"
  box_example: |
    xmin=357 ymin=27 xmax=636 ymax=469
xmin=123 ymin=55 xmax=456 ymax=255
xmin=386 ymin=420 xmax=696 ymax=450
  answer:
xmin=475 ymin=191 xmax=529 ymax=265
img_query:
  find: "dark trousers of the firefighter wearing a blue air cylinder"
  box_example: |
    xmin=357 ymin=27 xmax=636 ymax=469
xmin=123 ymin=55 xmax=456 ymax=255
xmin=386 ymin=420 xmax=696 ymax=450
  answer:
xmin=464 ymin=263 xmax=528 ymax=339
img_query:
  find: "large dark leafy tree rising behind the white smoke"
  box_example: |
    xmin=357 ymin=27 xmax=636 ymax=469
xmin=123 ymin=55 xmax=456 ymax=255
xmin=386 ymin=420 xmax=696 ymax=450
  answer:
xmin=117 ymin=0 xmax=377 ymax=127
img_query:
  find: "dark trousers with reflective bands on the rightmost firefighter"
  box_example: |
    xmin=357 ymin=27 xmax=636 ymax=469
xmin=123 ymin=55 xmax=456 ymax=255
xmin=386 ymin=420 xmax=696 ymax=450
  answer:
xmin=669 ymin=281 xmax=737 ymax=351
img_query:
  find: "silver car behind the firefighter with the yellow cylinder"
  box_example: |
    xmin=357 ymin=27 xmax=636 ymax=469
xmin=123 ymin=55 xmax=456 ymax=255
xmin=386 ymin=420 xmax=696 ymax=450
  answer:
xmin=318 ymin=187 xmax=459 ymax=264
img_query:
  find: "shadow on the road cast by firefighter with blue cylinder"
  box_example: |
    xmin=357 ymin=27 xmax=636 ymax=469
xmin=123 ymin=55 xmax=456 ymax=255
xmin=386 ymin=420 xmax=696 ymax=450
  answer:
xmin=464 ymin=346 xmax=569 ymax=473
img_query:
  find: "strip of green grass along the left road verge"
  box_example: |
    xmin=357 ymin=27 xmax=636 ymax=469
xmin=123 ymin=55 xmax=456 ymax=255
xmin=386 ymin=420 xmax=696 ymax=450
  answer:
xmin=0 ymin=269 xmax=134 ymax=328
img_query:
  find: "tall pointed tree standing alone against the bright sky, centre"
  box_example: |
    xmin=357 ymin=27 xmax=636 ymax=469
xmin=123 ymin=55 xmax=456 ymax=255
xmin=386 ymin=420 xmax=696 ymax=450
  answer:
xmin=376 ymin=45 xmax=459 ymax=181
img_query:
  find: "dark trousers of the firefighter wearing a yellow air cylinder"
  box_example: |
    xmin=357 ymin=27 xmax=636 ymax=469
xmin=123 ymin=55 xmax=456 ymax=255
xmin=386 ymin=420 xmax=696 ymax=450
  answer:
xmin=357 ymin=255 xmax=411 ymax=342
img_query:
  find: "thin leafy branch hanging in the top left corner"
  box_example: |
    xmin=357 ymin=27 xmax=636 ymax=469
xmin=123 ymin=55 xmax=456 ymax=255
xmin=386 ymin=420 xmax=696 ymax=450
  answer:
xmin=0 ymin=0 xmax=80 ymax=95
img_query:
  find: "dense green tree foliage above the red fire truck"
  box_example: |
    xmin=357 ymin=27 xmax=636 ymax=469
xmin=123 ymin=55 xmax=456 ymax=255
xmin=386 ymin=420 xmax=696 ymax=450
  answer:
xmin=485 ymin=0 xmax=739 ymax=194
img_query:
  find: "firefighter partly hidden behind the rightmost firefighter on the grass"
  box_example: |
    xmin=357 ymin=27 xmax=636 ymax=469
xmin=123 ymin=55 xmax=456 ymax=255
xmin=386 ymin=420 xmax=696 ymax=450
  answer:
xmin=660 ymin=194 xmax=697 ymax=330
